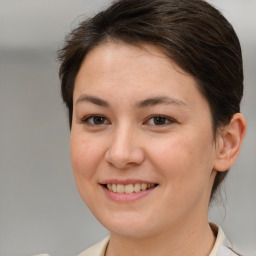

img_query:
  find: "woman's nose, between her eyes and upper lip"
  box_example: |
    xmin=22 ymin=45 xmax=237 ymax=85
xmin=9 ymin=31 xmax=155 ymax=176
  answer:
xmin=105 ymin=126 xmax=144 ymax=169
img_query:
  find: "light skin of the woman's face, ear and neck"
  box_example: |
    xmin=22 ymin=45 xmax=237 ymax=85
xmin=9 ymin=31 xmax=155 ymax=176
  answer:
xmin=70 ymin=42 xmax=246 ymax=256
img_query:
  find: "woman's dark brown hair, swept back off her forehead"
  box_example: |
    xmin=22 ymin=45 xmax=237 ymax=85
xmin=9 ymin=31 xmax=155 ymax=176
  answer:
xmin=58 ymin=0 xmax=243 ymax=202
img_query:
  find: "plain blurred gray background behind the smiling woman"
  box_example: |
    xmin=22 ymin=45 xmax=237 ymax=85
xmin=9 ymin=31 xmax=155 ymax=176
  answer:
xmin=0 ymin=0 xmax=256 ymax=256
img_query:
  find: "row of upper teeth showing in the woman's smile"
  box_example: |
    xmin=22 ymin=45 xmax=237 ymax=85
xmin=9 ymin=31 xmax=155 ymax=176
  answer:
xmin=107 ymin=183 xmax=155 ymax=194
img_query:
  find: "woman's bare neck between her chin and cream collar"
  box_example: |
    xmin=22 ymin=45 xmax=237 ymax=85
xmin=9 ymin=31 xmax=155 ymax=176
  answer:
xmin=106 ymin=218 xmax=215 ymax=256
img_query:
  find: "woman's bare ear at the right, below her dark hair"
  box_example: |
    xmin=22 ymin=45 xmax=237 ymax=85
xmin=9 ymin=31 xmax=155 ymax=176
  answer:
xmin=213 ymin=113 xmax=246 ymax=172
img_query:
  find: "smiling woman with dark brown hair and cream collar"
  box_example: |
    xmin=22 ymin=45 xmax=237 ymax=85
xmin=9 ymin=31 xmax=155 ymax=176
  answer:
xmin=59 ymin=0 xmax=246 ymax=256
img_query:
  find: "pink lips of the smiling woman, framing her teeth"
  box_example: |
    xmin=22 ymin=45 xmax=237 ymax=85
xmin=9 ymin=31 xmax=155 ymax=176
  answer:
xmin=99 ymin=179 xmax=158 ymax=203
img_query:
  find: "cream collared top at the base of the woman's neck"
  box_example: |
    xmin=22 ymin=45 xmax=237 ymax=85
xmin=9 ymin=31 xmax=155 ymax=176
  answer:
xmin=79 ymin=224 xmax=241 ymax=256
